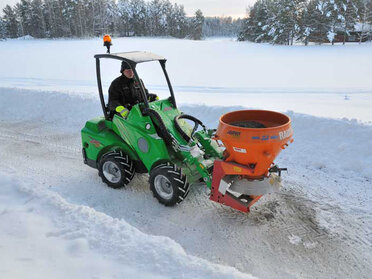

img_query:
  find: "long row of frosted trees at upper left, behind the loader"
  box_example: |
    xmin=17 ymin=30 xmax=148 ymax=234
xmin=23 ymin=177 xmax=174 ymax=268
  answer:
xmin=0 ymin=0 xmax=208 ymax=39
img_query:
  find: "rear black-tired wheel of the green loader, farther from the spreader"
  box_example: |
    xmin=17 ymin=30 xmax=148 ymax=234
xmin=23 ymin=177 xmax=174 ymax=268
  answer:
xmin=98 ymin=151 xmax=135 ymax=189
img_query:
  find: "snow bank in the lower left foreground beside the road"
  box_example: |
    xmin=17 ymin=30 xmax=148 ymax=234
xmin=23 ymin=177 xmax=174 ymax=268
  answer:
xmin=0 ymin=172 xmax=253 ymax=278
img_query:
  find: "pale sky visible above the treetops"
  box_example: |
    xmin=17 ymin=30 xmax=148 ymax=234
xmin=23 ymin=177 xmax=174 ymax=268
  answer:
xmin=0 ymin=0 xmax=256 ymax=17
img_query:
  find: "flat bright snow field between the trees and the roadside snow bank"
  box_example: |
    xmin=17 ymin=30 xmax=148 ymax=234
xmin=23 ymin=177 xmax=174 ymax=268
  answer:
xmin=0 ymin=38 xmax=372 ymax=122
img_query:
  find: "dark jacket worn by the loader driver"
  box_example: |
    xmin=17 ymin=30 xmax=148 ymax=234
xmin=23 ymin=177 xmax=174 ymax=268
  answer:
xmin=108 ymin=75 xmax=153 ymax=111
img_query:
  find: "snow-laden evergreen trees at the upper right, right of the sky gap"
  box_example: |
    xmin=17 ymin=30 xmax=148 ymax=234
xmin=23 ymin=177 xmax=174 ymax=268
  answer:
xmin=238 ymin=0 xmax=372 ymax=45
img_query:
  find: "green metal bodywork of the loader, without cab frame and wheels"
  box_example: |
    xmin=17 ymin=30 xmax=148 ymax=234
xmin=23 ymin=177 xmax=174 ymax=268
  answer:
xmin=81 ymin=99 xmax=222 ymax=187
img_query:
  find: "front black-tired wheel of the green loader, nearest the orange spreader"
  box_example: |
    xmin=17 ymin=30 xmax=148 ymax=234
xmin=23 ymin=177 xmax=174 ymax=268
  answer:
xmin=150 ymin=163 xmax=190 ymax=206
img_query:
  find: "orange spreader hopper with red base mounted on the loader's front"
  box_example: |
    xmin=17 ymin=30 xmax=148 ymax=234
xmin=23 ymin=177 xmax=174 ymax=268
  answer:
xmin=210 ymin=110 xmax=293 ymax=212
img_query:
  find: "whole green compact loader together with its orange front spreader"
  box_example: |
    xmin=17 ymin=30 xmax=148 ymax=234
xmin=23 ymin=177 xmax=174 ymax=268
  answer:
xmin=81 ymin=51 xmax=293 ymax=212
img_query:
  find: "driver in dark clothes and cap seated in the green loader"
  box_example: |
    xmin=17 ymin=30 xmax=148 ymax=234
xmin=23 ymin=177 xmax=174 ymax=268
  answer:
xmin=108 ymin=61 xmax=159 ymax=117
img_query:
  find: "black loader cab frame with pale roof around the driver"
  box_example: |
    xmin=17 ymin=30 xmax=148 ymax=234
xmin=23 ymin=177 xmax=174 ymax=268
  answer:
xmin=94 ymin=51 xmax=177 ymax=120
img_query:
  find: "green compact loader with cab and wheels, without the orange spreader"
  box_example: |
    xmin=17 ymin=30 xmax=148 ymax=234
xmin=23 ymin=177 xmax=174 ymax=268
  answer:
xmin=81 ymin=51 xmax=223 ymax=205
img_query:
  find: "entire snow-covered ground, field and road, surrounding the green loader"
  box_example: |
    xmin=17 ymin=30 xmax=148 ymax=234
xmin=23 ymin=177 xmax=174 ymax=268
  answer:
xmin=0 ymin=38 xmax=372 ymax=278
